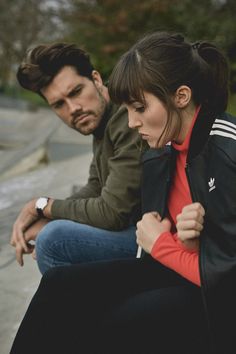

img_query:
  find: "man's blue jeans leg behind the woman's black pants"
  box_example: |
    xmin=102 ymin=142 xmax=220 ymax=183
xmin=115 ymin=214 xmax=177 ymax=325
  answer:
xmin=35 ymin=220 xmax=137 ymax=274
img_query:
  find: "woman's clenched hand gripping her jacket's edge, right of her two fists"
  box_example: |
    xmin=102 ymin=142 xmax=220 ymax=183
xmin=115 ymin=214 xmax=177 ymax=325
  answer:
xmin=176 ymin=203 xmax=205 ymax=250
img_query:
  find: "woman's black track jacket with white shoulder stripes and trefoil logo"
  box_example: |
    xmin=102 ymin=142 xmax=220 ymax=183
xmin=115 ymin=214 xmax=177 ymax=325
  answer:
xmin=142 ymin=110 xmax=236 ymax=354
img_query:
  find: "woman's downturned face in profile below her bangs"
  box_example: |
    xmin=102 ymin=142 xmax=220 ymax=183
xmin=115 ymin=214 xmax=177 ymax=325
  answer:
xmin=126 ymin=92 xmax=175 ymax=148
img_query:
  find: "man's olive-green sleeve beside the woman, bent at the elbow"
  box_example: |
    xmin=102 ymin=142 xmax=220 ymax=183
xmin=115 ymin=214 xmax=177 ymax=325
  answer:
xmin=52 ymin=109 xmax=141 ymax=230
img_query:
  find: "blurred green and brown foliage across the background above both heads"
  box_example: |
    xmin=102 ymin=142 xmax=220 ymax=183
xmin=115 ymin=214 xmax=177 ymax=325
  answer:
xmin=0 ymin=0 xmax=236 ymax=92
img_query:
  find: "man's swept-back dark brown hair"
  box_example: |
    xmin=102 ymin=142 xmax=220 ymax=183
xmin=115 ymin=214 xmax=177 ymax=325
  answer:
xmin=16 ymin=43 xmax=94 ymax=95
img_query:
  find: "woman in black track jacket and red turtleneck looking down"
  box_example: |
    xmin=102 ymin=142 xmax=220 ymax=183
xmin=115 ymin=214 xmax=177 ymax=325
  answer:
xmin=11 ymin=32 xmax=236 ymax=354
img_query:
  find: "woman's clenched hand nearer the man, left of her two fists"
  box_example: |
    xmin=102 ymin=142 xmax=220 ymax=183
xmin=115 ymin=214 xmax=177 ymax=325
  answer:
xmin=136 ymin=212 xmax=171 ymax=253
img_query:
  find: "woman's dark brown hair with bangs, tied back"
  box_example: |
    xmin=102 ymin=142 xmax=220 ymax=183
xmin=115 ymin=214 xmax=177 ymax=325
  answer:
xmin=109 ymin=32 xmax=228 ymax=141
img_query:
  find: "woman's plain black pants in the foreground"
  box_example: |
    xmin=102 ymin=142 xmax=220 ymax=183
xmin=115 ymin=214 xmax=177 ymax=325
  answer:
xmin=11 ymin=257 xmax=208 ymax=354
